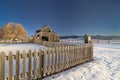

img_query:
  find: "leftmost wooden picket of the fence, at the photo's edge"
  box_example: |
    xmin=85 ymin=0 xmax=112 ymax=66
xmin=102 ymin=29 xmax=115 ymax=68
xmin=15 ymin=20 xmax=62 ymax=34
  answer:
xmin=0 ymin=52 xmax=5 ymax=80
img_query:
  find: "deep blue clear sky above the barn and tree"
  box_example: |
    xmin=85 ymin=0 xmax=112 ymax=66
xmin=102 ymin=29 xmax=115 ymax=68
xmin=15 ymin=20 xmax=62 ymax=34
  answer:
xmin=0 ymin=0 xmax=120 ymax=36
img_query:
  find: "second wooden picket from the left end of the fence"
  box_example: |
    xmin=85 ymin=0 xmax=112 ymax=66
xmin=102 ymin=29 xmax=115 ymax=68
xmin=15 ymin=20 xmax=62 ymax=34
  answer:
xmin=8 ymin=51 xmax=13 ymax=80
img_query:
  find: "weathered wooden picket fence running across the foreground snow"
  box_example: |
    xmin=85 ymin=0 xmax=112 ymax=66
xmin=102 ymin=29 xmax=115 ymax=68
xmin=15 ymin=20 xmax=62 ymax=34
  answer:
xmin=0 ymin=44 xmax=93 ymax=80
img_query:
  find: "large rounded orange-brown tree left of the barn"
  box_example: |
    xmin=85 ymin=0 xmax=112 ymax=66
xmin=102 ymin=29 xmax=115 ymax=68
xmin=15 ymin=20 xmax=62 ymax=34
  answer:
xmin=2 ymin=23 xmax=27 ymax=40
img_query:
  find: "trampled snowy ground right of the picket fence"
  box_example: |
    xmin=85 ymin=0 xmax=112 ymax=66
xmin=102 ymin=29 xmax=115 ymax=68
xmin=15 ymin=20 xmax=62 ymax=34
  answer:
xmin=43 ymin=44 xmax=120 ymax=80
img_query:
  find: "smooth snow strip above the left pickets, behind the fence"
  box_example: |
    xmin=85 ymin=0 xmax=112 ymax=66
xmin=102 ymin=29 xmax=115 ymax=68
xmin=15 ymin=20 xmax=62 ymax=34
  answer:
xmin=0 ymin=44 xmax=47 ymax=55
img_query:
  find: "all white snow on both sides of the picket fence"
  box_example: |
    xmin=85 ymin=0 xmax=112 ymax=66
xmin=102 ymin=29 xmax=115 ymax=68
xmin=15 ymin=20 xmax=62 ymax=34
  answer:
xmin=0 ymin=43 xmax=120 ymax=80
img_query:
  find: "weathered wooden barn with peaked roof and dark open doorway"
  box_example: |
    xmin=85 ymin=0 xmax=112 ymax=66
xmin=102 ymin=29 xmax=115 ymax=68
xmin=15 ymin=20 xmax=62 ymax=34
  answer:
xmin=34 ymin=25 xmax=60 ymax=42
